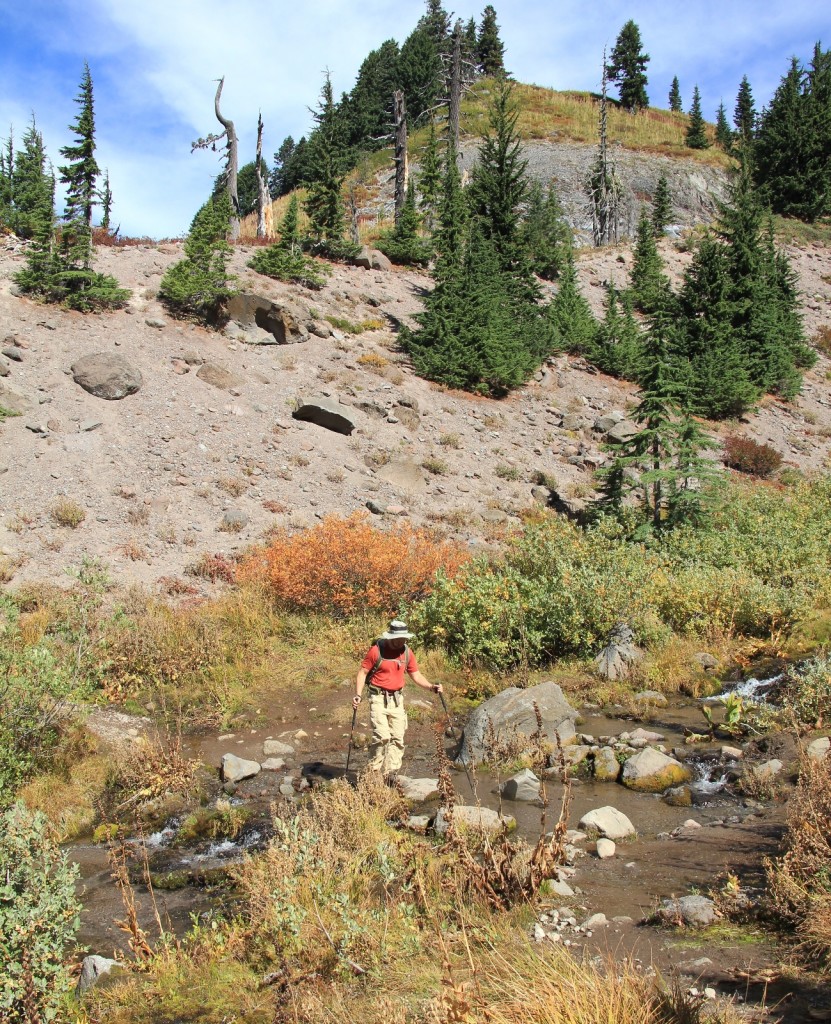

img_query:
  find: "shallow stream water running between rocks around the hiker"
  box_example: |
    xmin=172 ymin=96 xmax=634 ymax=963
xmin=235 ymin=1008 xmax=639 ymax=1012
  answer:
xmin=68 ymin=679 xmax=776 ymax=955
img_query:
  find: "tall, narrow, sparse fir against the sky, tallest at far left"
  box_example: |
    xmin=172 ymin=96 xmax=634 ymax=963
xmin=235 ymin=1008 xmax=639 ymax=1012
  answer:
xmin=58 ymin=63 xmax=100 ymax=272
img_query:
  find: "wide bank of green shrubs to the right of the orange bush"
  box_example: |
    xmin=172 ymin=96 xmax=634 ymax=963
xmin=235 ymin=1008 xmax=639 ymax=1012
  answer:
xmin=409 ymin=479 xmax=831 ymax=670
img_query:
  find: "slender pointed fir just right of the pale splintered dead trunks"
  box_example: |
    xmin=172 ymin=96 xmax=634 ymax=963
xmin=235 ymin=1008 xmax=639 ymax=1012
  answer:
xmin=306 ymin=72 xmax=347 ymax=243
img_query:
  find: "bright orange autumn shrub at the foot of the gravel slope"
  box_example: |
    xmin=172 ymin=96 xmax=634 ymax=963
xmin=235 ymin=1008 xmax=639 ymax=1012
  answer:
xmin=237 ymin=513 xmax=467 ymax=614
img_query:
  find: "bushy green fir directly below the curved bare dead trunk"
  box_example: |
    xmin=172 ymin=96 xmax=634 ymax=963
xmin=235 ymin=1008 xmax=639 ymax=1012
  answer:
xmin=159 ymin=189 xmax=231 ymax=323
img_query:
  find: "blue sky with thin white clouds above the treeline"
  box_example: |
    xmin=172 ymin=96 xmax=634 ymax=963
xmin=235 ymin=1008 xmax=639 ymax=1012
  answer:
xmin=0 ymin=0 xmax=831 ymax=238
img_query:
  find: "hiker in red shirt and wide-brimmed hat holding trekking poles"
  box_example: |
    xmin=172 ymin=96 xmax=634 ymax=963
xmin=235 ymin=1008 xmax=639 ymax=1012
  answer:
xmin=352 ymin=618 xmax=442 ymax=779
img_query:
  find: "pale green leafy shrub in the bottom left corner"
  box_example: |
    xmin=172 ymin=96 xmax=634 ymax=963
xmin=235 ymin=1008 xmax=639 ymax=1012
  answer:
xmin=0 ymin=803 xmax=81 ymax=1024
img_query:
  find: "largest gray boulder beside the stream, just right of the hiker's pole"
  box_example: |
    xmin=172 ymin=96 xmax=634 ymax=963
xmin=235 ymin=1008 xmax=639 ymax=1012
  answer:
xmin=458 ymin=682 xmax=577 ymax=764
